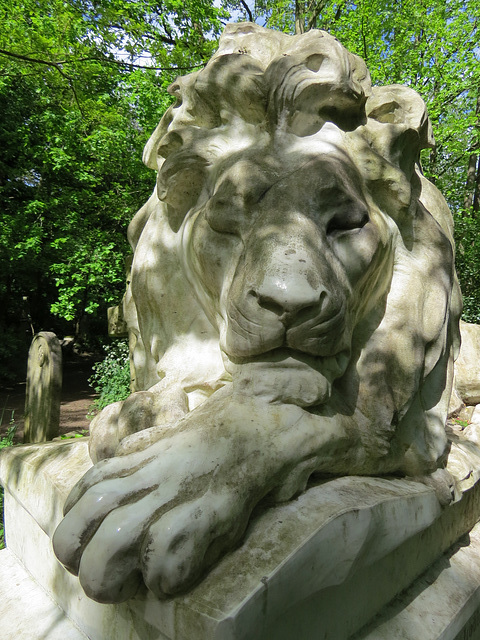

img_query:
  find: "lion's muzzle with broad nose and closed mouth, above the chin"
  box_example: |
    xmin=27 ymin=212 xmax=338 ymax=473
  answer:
xmin=225 ymin=216 xmax=348 ymax=358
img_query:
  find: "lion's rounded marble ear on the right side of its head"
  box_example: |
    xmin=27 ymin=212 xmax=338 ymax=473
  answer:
xmin=365 ymin=84 xmax=435 ymax=179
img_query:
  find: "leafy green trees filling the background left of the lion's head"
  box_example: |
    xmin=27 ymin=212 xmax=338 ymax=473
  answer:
xmin=0 ymin=0 xmax=227 ymax=370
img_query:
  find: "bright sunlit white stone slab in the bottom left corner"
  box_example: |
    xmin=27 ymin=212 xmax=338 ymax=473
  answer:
xmin=0 ymin=549 xmax=87 ymax=640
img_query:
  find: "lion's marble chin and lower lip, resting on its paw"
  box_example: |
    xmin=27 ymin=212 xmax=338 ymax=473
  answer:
xmin=228 ymin=349 xmax=349 ymax=407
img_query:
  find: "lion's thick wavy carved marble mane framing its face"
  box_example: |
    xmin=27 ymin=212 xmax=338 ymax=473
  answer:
xmin=125 ymin=23 xmax=460 ymax=473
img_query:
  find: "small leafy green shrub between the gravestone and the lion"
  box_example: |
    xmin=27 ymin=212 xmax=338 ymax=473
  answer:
xmin=88 ymin=340 xmax=130 ymax=411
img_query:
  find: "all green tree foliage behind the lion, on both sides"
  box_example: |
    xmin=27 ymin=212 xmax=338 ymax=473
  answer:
xmin=0 ymin=0 xmax=480 ymax=362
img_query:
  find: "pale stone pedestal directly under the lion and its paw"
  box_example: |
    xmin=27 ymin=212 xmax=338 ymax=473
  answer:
xmin=0 ymin=439 xmax=480 ymax=640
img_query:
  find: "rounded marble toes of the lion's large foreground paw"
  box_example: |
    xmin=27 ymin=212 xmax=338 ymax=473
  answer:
xmin=54 ymin=456 xmax=251 ymax=602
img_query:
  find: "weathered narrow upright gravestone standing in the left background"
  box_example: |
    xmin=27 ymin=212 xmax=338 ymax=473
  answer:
xmin=23 ymin=331 xmax=63 ymax=442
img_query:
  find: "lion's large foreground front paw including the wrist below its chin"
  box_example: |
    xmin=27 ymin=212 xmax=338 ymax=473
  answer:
xmin=53 ymin=392 xmax=323 ymax=602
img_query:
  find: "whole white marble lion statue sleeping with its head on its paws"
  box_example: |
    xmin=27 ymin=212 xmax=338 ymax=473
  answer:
xmin=54 ymin=23 xmax=461 ymax=602
